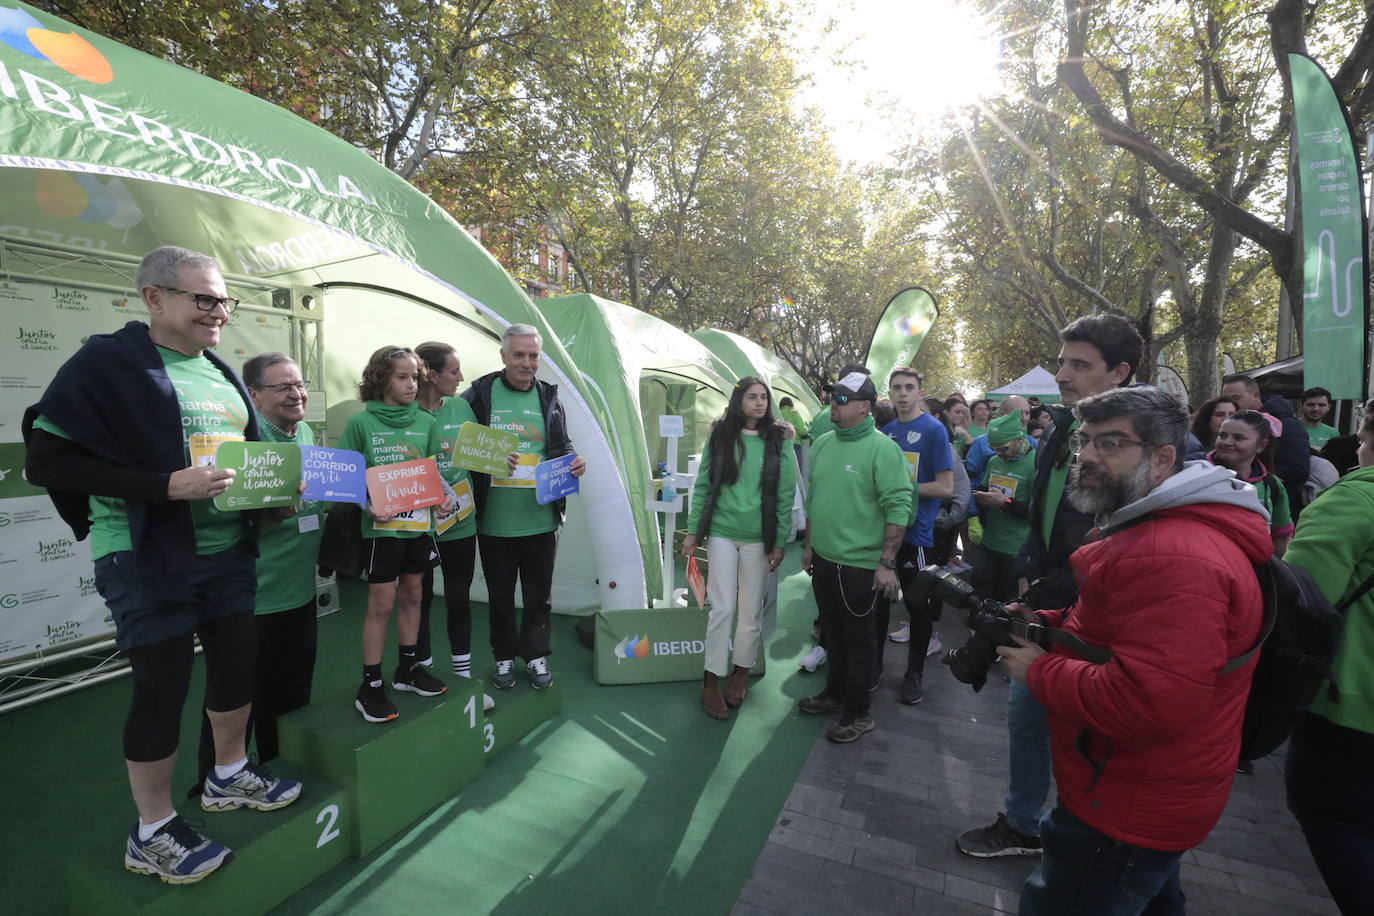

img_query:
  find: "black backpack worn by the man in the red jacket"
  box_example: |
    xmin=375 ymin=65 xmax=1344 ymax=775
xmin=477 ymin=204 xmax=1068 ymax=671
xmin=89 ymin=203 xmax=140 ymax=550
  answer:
xmin=1221 ymin=556 xmax=1374 ymax=761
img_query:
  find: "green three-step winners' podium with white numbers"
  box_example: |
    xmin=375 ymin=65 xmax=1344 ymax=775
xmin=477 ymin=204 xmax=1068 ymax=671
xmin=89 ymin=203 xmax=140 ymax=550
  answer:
xmin=69 ymin=677 xmax=562 ymax=916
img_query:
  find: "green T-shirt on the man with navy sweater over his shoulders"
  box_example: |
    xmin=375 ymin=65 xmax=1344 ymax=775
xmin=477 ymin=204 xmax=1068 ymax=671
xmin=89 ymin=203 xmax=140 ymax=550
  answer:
xmin=33 ymin=346 xmax=249 ymax=560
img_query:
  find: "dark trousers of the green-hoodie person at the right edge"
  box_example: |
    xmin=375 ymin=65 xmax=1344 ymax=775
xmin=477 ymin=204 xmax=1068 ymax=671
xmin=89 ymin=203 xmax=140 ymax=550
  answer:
xmin=1285 ymin=713 xmax=1374 ymax=913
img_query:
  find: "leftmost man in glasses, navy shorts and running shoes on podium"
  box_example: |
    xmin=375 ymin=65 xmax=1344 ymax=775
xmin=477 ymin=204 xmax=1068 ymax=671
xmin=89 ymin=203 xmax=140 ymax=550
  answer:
xmin=23 ymin=247 xmax=301 ymax=884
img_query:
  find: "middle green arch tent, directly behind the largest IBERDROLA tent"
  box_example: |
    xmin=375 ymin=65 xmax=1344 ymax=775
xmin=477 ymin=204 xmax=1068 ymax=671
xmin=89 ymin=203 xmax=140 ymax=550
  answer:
xmin=539 ymin=293 xmax=738 ymax=595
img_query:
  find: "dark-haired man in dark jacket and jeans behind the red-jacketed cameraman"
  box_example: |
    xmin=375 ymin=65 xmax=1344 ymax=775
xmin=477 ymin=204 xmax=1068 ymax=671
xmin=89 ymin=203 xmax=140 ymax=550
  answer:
xmin=956 ymin=314 xmax=1143 ymax=858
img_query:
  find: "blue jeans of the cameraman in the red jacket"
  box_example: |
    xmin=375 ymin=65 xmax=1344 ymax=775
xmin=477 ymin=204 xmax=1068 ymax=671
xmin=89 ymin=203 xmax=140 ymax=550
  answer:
xmin=1017 ymin=805 xmax=1186 ymax=916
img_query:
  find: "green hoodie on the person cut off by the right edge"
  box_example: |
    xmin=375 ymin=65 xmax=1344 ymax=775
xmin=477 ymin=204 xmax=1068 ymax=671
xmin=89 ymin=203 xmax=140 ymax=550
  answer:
xmin=1283 ymin=467 xmax=1374 ymax=733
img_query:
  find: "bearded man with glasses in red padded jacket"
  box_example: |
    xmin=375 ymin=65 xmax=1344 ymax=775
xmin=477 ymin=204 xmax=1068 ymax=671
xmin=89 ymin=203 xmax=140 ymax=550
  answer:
xmin=998 ymin=387 xmax=1270 ymax=915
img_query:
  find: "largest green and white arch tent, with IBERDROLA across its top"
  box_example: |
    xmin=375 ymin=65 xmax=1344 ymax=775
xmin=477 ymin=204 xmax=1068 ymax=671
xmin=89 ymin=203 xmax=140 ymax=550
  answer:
xmin=0 ymin=4 xmax=653 ymax=681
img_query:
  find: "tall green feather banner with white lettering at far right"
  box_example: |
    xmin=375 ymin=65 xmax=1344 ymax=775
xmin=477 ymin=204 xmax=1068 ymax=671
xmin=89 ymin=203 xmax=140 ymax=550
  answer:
xmin=1287 ymin=54 xmax=1369 ymax=398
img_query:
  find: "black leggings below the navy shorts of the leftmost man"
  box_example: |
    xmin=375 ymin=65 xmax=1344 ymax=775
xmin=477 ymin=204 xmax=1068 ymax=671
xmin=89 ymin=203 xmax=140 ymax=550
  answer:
xmin=124 ymin=612 xmax=257 ymax=764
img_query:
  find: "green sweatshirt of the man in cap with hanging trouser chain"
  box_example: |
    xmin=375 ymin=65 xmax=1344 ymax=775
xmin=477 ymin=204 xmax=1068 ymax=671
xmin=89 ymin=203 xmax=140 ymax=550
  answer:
xmin=807 ymin=416 xmax=914 ymax=570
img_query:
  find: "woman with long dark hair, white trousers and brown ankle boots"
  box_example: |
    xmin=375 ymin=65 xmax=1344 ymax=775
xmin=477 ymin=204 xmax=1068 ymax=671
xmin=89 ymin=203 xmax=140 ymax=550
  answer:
xmin=683 ymin=376 xmax=797 ymax=718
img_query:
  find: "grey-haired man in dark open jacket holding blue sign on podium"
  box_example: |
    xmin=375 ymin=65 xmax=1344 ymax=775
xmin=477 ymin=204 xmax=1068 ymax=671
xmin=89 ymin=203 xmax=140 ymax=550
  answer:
xmin=463 ymin=324 xmax=587 ymax=689
